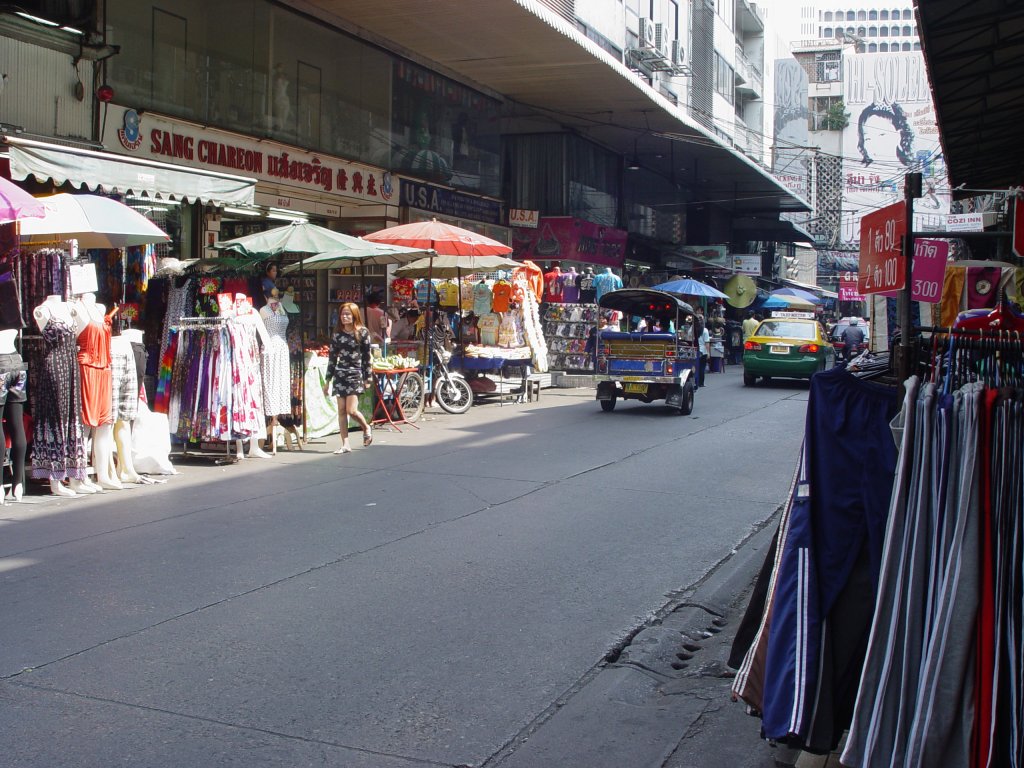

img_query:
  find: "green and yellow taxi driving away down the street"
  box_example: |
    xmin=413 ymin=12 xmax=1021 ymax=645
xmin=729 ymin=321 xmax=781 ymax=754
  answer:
xmin=743 ymin=315 xmax=836 ymax=387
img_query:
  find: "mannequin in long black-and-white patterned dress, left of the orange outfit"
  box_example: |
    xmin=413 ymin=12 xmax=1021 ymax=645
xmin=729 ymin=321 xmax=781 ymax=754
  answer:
xmin=32 ymin=295 xmax=88 ymax=496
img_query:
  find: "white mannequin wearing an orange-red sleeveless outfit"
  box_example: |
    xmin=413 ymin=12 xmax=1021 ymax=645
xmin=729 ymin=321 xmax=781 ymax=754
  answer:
xmin=71 ymin=293 xmax=124 ymax=490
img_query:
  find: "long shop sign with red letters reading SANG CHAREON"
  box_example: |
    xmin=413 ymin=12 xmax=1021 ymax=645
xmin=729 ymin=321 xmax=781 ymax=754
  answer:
xmin=102 ymin=104 xmax=396 ymax=205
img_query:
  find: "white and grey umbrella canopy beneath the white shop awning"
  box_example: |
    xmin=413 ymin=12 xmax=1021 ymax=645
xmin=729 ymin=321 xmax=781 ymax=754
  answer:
xmin=20 ymin=195 xmax=170 ymax=248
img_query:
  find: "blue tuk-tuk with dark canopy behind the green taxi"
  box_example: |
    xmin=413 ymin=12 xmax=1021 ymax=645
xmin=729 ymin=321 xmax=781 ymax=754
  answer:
xmin=594 ymin=288 xmax=702 ymax=416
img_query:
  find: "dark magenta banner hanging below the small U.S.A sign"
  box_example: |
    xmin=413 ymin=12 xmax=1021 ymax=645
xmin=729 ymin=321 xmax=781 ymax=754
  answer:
xmin=512 ymin=216 xmax=627 ymax=267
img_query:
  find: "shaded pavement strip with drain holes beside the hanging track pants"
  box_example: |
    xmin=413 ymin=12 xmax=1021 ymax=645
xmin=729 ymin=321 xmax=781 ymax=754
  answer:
xmin=487 ymin=515 xmax=839 ymax=768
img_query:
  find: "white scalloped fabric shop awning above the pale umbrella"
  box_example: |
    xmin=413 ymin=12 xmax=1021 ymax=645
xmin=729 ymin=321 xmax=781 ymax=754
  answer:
xmin=6 ymin=137 xmax=256 ymax=205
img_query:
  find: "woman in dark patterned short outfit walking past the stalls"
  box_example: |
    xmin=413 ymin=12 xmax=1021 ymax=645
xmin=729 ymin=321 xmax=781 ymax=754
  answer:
xmin=324 ymin=302 xmax=374 ymax=454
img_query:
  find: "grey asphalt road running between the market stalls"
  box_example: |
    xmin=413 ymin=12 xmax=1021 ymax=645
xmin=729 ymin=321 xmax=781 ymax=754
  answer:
xmin=0 ymin=369 xmax=807 ymax=768
